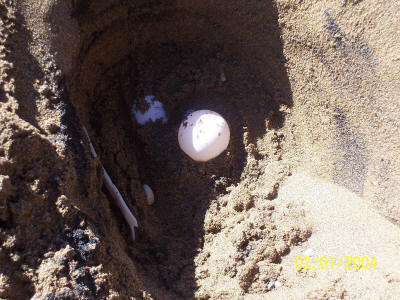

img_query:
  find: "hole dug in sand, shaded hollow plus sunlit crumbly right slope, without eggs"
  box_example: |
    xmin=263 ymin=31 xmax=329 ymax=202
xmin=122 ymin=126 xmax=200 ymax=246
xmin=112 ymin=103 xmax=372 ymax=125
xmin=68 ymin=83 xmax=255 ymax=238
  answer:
xmin=71 ymin=1 xmax=310 ymax=299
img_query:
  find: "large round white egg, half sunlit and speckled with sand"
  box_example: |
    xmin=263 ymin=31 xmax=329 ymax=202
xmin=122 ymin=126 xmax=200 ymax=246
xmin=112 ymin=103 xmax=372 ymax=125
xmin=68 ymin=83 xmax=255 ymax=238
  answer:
xmin=178 ymin=110 xmax=230 ymax=162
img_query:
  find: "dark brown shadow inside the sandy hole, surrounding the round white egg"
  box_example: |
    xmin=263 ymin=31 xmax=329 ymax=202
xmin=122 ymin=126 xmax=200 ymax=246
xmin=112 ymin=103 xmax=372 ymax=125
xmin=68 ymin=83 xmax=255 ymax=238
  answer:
xmin=79 ymin=1 xmax=292 ymax=299
